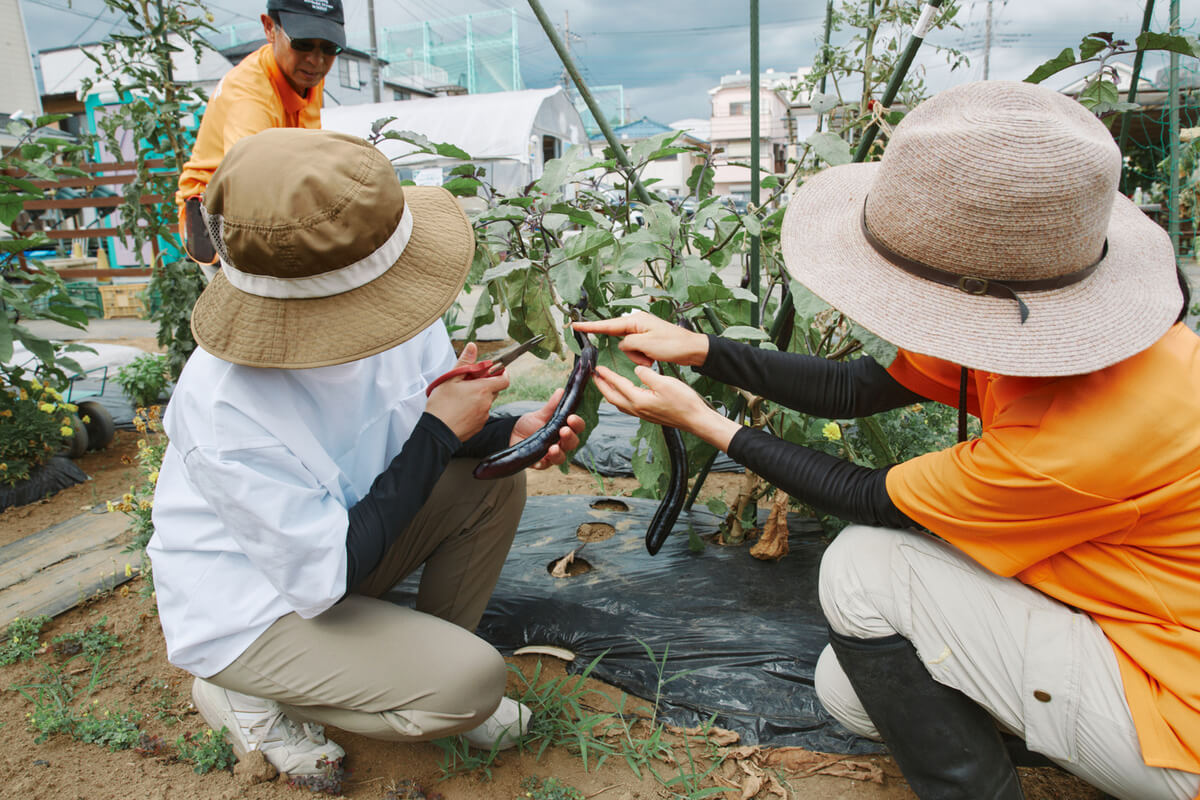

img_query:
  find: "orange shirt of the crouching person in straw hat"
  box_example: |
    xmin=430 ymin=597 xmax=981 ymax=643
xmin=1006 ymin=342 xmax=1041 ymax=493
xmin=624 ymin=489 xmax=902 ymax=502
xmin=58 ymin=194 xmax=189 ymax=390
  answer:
xmin=887 ymin=323 xmax=1200 ymax=772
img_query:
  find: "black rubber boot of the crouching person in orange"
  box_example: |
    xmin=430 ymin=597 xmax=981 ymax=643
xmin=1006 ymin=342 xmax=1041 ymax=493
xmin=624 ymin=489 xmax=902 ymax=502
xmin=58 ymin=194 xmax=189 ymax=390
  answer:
xmin=829 ymin=630 xmax=1025 ymax=800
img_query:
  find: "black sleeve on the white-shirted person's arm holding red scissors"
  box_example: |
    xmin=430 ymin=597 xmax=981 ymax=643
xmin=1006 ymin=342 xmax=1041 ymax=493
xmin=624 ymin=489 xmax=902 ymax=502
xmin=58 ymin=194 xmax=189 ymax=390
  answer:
xmin=346 ymin=414 xmax=462 ymax=593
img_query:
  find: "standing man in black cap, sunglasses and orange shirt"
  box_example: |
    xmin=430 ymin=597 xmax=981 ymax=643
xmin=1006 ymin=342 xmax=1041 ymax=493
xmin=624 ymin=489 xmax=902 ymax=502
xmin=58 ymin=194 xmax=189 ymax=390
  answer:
xmin=175 ymin=0 xmax=346 ymax=277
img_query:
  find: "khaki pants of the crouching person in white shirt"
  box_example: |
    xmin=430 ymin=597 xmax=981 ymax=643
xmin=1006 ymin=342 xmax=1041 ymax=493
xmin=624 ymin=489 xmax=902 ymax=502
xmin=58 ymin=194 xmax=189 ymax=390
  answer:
xmin=208 ymin=459 xmax=526 ymax=741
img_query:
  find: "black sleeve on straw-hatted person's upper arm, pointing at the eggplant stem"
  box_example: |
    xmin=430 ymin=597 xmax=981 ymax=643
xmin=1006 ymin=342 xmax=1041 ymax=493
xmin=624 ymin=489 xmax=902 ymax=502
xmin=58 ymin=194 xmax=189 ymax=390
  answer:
xmin=697 ymin=336 xmax=926 ymax=420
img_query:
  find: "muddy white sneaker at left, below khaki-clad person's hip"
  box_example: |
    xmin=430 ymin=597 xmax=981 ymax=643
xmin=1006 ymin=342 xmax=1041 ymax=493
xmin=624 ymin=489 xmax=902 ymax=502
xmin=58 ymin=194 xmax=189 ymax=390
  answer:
xmin=192 ymin=678 xmax=346 ymax=775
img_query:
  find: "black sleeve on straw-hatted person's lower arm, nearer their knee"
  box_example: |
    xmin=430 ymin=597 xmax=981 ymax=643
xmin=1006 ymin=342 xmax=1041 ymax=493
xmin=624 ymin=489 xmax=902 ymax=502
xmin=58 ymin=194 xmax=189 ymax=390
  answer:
xmin=728 ymin=428 xmax=917 ymax=528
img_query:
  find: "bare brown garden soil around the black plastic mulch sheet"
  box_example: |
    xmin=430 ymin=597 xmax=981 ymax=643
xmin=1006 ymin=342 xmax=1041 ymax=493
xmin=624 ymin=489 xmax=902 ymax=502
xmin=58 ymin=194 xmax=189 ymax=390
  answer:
xmin=0 ymin=342 xmax=1103 ymax=800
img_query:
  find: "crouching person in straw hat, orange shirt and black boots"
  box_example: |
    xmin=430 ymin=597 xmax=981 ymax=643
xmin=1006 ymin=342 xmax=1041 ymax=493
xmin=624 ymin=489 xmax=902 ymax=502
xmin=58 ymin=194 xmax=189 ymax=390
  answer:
xmin=576 ymin=80 xmax=1200 ymax=800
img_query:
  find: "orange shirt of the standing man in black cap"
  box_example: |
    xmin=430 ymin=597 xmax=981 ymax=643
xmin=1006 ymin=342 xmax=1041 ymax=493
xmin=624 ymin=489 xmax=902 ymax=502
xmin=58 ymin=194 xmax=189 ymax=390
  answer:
xmin=175 ymin=44 xmax=325 ymax=215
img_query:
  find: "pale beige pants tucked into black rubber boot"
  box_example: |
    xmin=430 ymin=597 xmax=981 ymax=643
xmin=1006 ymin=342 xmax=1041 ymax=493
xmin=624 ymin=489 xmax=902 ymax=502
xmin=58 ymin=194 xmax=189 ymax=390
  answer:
xmin=816 ymin=525 xmax=1200 ymax=800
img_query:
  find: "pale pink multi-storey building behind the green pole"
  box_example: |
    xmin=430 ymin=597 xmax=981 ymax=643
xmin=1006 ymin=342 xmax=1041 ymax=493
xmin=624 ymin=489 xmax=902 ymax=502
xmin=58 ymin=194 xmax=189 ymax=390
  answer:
xmin=708 ymin=70 xmax=816 ymax=201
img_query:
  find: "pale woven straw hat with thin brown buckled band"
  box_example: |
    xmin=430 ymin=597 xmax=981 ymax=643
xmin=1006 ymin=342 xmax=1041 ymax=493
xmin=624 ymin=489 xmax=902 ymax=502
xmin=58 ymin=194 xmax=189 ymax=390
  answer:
xmin=782 ymin=82 xmax=1183 ymax=375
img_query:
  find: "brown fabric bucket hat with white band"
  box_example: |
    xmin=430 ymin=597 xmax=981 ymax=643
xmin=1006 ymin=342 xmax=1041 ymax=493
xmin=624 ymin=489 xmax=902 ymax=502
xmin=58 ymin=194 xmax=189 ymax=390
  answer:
xmin=192 ymin=128 xmax=475 ymax=369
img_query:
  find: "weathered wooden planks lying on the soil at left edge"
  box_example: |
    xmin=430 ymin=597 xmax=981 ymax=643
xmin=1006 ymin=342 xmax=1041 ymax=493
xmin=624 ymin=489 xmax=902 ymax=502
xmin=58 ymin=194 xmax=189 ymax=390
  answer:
xmin=0 ymin=512 xmax=139 ymax=636
